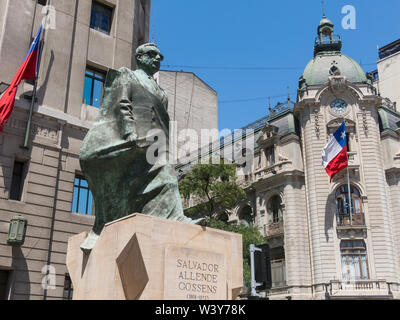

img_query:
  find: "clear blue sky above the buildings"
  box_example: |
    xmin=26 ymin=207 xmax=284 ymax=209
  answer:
xmin=150 ymin=0 xmax=400 ymax=130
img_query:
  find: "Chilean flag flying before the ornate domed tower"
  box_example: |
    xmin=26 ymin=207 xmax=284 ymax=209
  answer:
xmin=322 ymin=122 xmax=349 ymax=180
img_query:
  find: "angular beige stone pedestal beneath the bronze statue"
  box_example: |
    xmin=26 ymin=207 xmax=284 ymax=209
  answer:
xmin=67 ymin=214 xmax=243 ymax=300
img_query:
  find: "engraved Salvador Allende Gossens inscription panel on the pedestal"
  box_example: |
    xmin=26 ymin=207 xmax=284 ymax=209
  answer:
xmin=164 ymin=246 xmax=227 ymax=300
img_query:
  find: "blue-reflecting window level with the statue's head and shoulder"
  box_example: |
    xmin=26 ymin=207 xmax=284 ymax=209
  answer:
xmin=83 ymin=67 xmax=106 ymax=108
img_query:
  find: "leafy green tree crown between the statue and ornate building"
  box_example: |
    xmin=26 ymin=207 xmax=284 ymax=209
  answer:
xmin=179 ymin=160 xmax=246 ymax=221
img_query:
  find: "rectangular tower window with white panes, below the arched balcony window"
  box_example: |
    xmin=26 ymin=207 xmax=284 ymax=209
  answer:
xmin=340 ymin=240 xmax=369 ymax=281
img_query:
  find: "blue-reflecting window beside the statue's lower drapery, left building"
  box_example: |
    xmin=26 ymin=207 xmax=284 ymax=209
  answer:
xmin=72 ymin=176 xmax=93 ymax=215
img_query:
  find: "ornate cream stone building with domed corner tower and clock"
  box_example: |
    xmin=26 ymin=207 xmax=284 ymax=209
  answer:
xmin=225 ymin=17 xmax=400 ymax=299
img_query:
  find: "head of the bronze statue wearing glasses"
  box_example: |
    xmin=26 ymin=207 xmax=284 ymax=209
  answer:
xmin=136 ymin=43 xmax=164 ymax=75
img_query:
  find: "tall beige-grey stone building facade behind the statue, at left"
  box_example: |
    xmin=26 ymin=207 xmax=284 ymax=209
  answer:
xmin=0 ymin=0 xmax=150 ymax=299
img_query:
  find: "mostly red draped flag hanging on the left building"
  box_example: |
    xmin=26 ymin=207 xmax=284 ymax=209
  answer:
xmin=0 ymin=26 xmax=42 ymax=131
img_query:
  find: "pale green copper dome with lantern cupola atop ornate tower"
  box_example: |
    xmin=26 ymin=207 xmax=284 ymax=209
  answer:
xmin=299 ymin=16 xmax=367 ymax=89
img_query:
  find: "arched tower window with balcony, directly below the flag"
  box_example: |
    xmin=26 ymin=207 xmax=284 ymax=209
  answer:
xmin=336 ymin=185 xmax=364 ymax=226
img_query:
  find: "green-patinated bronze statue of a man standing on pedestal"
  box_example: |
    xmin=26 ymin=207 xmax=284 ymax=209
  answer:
xmin=80 ymin=44 xmax=199 ymax=252
